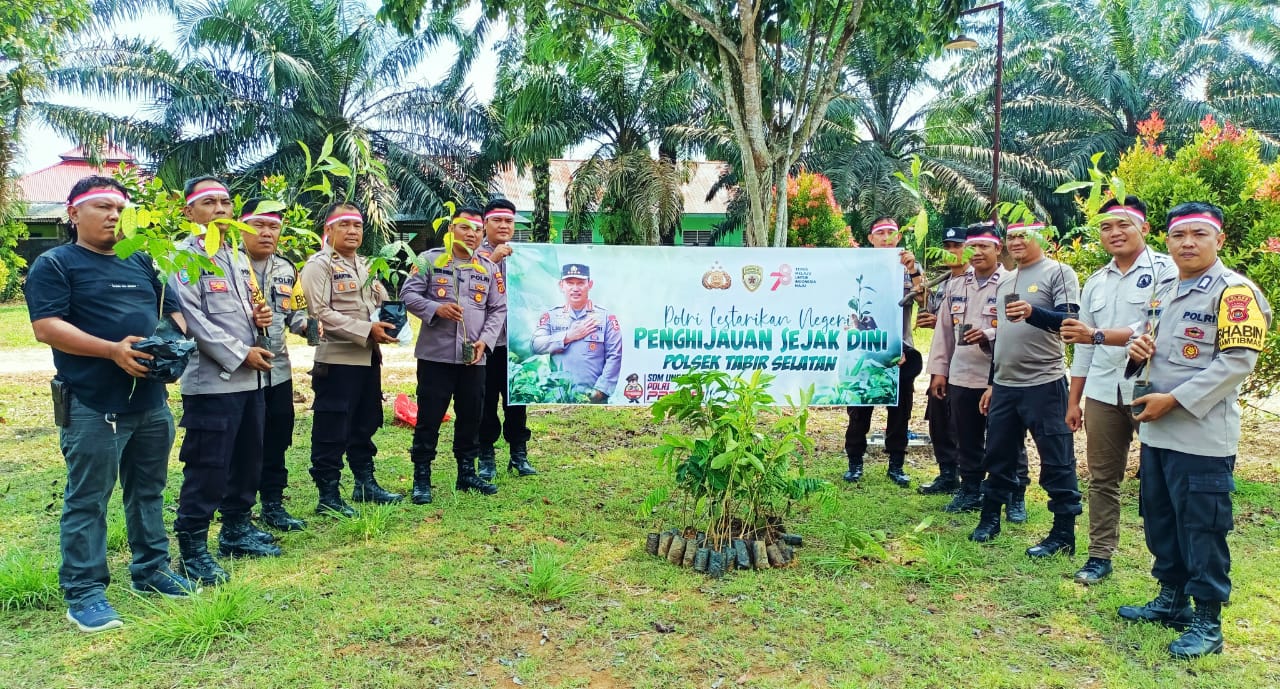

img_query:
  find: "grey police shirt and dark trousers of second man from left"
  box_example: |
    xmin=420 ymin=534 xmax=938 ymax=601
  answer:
xmin=169 ymin=237 xmax=266 ymax=531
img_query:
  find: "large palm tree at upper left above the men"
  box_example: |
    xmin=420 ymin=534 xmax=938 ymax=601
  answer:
xmin=38 ymin=0 xmax=485 ymax=227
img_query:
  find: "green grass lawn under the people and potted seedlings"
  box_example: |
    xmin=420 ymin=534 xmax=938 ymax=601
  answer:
xmin=0 ymin=370 xmax=1280 ymax=689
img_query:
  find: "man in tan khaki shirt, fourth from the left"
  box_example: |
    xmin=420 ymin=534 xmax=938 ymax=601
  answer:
xmin=302 ymin=202 xmax=404 ymax=516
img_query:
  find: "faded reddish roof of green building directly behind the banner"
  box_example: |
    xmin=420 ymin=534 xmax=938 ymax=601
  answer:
xmin=490 ymin=159 xmax=730 ymax=214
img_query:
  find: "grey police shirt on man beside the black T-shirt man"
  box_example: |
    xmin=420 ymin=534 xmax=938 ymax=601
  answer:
xmin=169 ymin=237 xmax=262 ymax=394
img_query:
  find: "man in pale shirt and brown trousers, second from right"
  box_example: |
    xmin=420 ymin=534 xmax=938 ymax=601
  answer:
xmin=1062 ymin=196 xmax=1176 ymax=585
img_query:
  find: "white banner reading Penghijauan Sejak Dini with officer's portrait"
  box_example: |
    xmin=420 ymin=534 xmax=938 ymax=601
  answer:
xmin=507 ymin=243 xmax=905 ymax=406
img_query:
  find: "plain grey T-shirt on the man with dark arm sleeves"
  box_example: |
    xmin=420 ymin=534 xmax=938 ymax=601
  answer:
xmin=993 ymin=256 xmax=1080 ymax=388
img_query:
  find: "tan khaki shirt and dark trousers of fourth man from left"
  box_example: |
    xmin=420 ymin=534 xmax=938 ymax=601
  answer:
xmin=301 ymin=245 xmax=387 ymax=483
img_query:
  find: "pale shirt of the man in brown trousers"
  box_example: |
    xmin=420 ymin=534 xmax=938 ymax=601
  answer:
xmin=1071 ymin=250 xmax=1178 ymax=405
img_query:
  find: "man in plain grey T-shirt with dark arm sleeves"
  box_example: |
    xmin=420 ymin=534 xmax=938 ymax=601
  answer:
xmin=969 ymin=223 xmax=1082 ymax=557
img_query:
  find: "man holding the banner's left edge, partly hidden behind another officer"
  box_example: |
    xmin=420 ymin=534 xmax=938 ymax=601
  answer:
xmin=477 ymin=199 xmax=538 ymax=482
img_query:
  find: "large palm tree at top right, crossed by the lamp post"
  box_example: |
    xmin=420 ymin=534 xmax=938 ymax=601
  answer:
xmin=929 ymin=0 xmax=1280 ymax=215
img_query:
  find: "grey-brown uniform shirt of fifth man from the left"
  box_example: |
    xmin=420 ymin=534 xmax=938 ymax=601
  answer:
xmin=401 ymin=248 xmax=507 ymax=364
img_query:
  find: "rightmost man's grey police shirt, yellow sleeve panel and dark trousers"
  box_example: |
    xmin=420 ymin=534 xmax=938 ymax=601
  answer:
xmin=1138 ymin=261 xmax=1271 ymax=603
